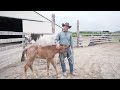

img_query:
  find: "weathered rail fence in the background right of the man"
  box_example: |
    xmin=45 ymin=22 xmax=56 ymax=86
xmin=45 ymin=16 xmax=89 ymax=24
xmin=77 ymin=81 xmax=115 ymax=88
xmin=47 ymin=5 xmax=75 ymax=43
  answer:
xmin=74 ymin=34 xmax=120 ymax=47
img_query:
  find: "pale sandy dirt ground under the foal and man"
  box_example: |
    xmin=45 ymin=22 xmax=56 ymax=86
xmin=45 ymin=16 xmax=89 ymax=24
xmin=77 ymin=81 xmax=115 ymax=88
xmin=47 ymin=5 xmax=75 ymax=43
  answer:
xmin=0 ymin=43 xmax=120 ymax=79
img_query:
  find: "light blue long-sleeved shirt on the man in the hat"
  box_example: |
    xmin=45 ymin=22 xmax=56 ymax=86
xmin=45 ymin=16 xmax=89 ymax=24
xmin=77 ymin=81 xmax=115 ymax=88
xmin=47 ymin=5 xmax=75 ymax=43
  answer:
xmin=55 ymin=31 xmax=73 ymax=48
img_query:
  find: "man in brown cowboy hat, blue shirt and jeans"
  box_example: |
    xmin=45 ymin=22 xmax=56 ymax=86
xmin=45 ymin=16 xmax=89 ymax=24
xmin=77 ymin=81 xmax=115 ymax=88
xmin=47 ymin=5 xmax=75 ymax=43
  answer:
xmin=55 ymin=22 xmax=76 ymax=76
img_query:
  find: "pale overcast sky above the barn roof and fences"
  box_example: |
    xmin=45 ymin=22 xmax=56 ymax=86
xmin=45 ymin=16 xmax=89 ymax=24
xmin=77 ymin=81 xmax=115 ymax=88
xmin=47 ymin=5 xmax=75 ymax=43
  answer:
xmin=37 ymin=11 xmax=120 ymax=32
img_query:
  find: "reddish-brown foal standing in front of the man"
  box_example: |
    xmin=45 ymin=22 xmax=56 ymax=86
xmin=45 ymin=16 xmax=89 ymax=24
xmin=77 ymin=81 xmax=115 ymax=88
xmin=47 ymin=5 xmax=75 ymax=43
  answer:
xmin=21 ymin=45 xmax=67 ymax=78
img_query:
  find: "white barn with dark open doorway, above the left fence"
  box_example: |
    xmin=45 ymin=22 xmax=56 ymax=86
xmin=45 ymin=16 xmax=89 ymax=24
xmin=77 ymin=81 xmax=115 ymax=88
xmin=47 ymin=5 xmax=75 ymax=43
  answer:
xmin=0 ymin=11 xmax=61 ymax=33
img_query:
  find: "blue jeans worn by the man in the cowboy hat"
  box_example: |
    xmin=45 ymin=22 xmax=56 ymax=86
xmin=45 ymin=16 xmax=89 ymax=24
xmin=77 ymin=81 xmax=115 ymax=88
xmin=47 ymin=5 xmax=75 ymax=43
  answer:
xmin=59 ymin=47 xmax=74 ymax=73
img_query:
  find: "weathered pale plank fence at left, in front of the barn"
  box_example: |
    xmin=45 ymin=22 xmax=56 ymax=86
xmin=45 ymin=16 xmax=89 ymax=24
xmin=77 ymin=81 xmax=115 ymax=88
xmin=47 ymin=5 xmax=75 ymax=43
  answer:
xmin=0 ymin=31 xmax=52 ymax=69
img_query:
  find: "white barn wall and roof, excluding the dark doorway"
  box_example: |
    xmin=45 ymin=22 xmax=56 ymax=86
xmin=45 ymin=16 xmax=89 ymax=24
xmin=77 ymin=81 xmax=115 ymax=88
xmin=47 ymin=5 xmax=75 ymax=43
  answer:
xmin=0 ymin=11 xmax=52 ymax=33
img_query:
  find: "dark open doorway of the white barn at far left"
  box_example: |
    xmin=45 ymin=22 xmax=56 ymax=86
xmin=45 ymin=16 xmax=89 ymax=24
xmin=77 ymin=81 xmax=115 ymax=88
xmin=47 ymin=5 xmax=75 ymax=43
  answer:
xmin=0 ymin=16 xmax=23 ymax=39
